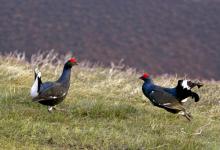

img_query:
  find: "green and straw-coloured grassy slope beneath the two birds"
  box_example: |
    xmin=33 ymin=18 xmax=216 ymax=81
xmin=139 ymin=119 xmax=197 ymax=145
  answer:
xmin=0 ymin=56 xmax=220 ymax=150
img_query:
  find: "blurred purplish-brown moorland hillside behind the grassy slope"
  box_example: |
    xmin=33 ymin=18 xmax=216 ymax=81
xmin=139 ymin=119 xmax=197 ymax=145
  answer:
xmin=0 ymin=0 xmax=220 ymax=80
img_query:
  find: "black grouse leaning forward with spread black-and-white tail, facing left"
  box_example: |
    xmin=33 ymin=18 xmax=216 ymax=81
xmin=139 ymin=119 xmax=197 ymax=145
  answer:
xmin=140 ymin=73 xmax=202 ymax=121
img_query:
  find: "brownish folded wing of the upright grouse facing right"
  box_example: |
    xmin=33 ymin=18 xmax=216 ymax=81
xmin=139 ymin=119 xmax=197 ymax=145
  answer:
xmin=33 ymin=82 xmax=66 ymax=102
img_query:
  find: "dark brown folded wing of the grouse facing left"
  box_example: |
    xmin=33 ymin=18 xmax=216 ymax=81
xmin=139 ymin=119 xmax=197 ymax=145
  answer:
xmin=149 ymin=90 xmax=185 ymax=111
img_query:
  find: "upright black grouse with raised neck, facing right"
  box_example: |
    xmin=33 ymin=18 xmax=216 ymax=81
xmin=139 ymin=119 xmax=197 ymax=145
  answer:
xmin=31 ymin=58 xmax=77 ymax=112
